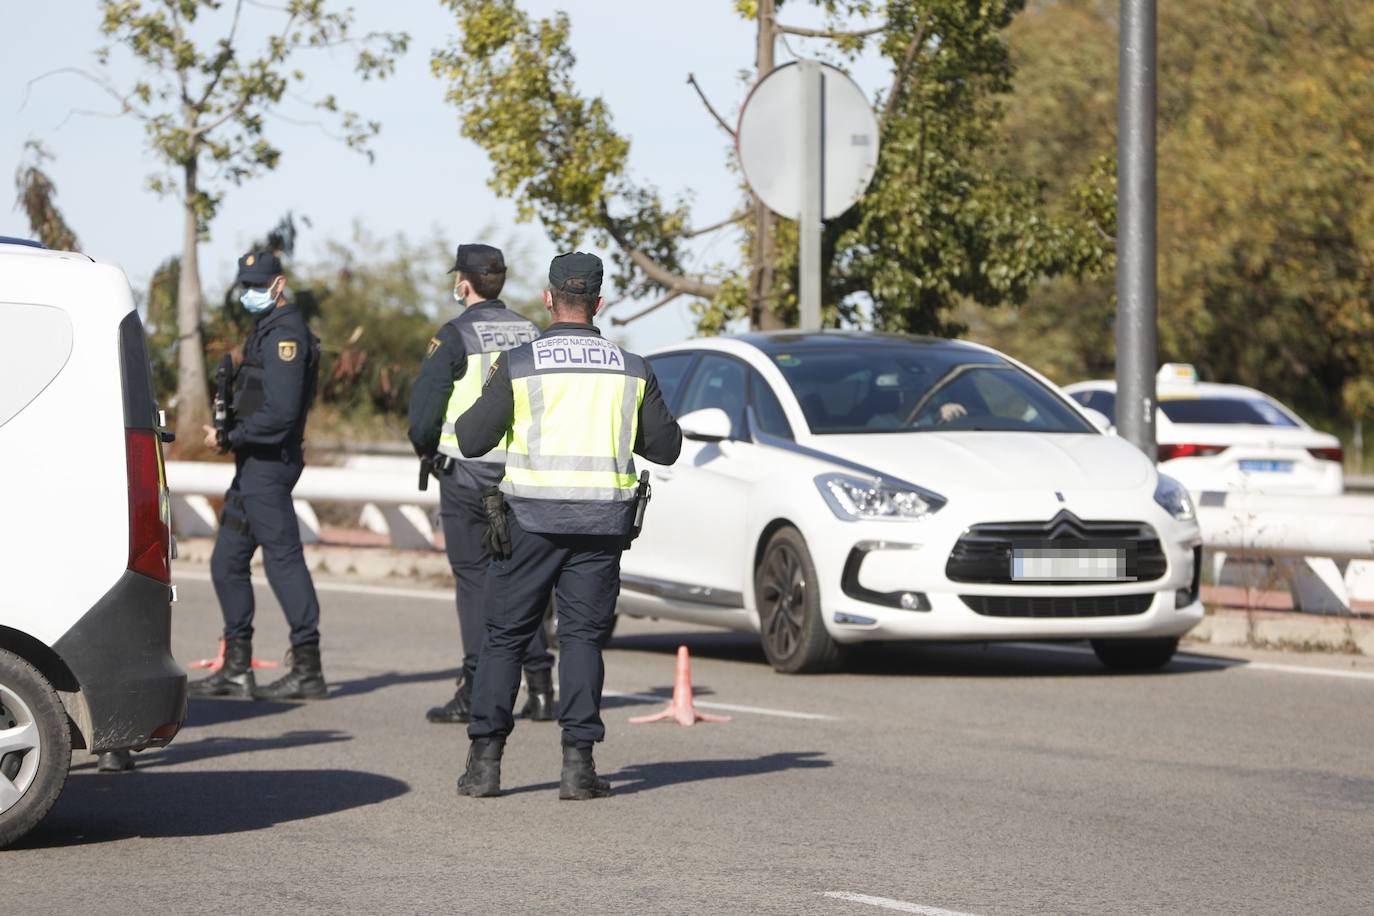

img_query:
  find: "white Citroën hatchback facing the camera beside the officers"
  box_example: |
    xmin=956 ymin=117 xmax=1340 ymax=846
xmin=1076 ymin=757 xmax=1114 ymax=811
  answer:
xmin=618 ymin=331 xmax=1202 ymax=672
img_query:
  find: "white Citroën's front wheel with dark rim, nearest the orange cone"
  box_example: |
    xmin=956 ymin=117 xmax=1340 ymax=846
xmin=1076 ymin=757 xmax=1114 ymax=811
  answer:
xmin=754 ymin=527 xmax=841 ymax=674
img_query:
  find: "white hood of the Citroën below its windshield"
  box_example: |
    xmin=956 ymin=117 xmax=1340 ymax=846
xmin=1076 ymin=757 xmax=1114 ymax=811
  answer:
xmin=808 ymin=433 xmax=1154 ymax=493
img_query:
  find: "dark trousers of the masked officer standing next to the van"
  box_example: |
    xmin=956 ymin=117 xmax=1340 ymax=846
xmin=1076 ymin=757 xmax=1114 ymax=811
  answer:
xmin=210 ymin=448 xmax=320 ymax=647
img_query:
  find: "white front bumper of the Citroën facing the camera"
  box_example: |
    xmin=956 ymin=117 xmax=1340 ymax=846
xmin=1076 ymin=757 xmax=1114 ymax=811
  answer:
xmin=818 ymin=512 xmax=1202 ymax=643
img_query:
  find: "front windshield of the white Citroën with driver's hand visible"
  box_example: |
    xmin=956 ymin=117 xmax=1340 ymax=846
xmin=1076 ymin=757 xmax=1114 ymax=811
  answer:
xmin=771 ymin=343 xmax=1096 ymax=434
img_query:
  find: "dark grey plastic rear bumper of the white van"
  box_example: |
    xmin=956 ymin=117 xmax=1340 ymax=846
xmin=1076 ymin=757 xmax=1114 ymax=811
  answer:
xmin=54 ymin=573 xmax=187 ymax=753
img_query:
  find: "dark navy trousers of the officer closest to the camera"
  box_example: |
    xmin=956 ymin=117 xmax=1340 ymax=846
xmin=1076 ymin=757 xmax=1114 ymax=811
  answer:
xmin=467 ymin=514 xmax=624 ymax=747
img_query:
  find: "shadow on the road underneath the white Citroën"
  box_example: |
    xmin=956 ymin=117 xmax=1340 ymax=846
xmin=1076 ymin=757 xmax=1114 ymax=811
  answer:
xmin=609 ymin=630 xmax=1208 ymax=678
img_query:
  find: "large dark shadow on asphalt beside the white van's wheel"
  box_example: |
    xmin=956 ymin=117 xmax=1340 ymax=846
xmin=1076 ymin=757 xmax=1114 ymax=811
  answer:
xmin=16 ymin=769 xmax=409 ymax=849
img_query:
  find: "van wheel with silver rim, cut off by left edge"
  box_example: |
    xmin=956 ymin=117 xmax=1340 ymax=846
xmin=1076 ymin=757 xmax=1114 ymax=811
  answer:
xmin=0 ymin=650 xmax=71 ymax=849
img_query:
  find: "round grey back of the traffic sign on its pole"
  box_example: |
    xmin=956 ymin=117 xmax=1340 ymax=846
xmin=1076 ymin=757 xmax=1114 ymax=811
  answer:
xmin=735 ymin=62 xmax=878 ymax=220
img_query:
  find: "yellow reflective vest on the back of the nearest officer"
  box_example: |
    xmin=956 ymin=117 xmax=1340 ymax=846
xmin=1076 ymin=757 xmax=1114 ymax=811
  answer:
xmin=502 ymin=336 xmax=646 ymax=519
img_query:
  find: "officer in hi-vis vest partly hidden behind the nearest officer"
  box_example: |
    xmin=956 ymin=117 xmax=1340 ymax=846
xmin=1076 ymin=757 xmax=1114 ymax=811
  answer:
xmin=409 ymin=244 xmax=554 ymax=722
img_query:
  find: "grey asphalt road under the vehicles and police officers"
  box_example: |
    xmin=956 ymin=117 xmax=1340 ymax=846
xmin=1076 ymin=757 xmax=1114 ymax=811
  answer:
xmin=0 ymin=567 xmax=1374 ymax=916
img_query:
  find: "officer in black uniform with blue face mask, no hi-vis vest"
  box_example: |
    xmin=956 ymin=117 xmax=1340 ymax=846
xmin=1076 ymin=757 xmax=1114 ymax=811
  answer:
xmin=190 ymin=251 xmax=326 ymax=700
